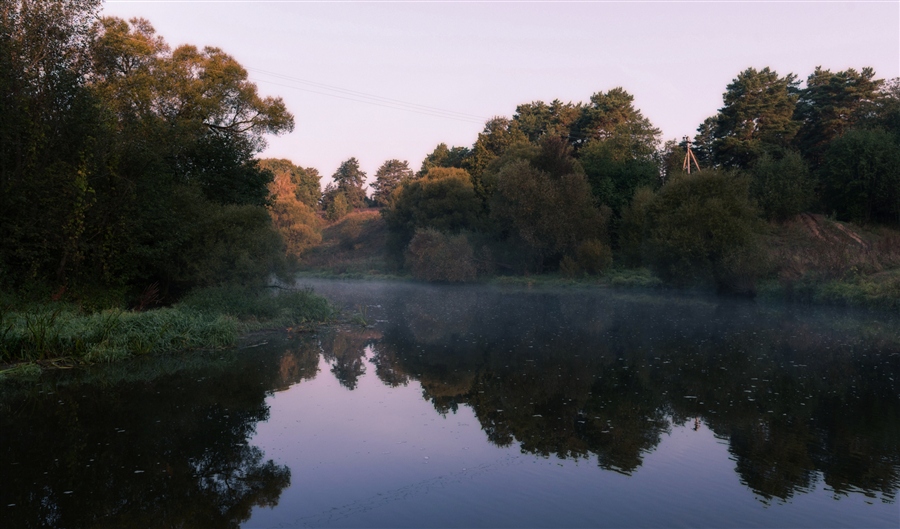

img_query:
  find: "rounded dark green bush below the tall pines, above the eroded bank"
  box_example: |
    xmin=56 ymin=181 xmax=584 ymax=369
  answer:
xmin=750 ymin=151 xmax=815 ymax=221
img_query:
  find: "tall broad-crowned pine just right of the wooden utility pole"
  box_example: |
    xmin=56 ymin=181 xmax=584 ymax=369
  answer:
xmin=713 ymin=68 xmax=800 ymax=168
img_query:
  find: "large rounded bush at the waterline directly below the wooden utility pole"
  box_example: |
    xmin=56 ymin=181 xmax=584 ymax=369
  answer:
xmin=644 ymin=170 xmax=762 ymax=292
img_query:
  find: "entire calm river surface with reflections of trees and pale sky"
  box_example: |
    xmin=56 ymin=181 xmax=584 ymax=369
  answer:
xmin=0 ymin=281 xmax=900 ymax=528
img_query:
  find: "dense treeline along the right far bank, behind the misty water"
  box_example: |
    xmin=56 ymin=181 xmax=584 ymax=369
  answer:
xmin=323 ymin=68 xmax=900 ymax=292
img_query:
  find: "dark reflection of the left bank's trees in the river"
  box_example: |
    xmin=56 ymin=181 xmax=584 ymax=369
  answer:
xmin=0 ymin=341 xmax=319 ymax=528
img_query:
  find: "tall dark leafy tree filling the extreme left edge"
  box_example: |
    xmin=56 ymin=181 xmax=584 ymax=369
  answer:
xmin=0 ymin=0 xmax=102 ymax=283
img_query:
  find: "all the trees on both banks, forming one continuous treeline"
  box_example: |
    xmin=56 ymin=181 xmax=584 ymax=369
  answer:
xmin=0 ymin=0 xmax=900 ymax=305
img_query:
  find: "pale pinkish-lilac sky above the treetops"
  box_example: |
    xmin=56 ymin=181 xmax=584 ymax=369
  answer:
xmin=103 ymin=0 xmax=900 ymax=186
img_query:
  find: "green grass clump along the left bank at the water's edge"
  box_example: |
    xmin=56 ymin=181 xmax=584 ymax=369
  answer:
xmin=0 ymin=287 xmax=338 ymax=378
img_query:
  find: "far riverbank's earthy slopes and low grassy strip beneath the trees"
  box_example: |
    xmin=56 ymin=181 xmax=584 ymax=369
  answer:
xmin=300 ymin=210 xmax=900 ymax=310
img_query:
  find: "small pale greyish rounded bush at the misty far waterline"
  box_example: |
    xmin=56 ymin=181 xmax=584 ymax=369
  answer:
xmin=406 ymin=228 xmax=476 ymax=283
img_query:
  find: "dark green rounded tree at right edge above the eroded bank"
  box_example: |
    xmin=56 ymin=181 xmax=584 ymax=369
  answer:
xmin=821 ymin=129 xmax=900 ymax=223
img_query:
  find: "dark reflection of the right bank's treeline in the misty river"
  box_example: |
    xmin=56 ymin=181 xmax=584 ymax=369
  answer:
xmin=308 ymin=285 xmax=900 ymax=502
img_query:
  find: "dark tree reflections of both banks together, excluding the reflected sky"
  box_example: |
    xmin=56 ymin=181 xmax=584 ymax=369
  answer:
xmin=0 ymin=283 xmax=900 ymax=527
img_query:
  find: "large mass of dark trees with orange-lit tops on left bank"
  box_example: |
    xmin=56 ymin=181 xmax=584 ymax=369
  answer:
xmin=0 ymin=0 xmax=302 ymax=299
